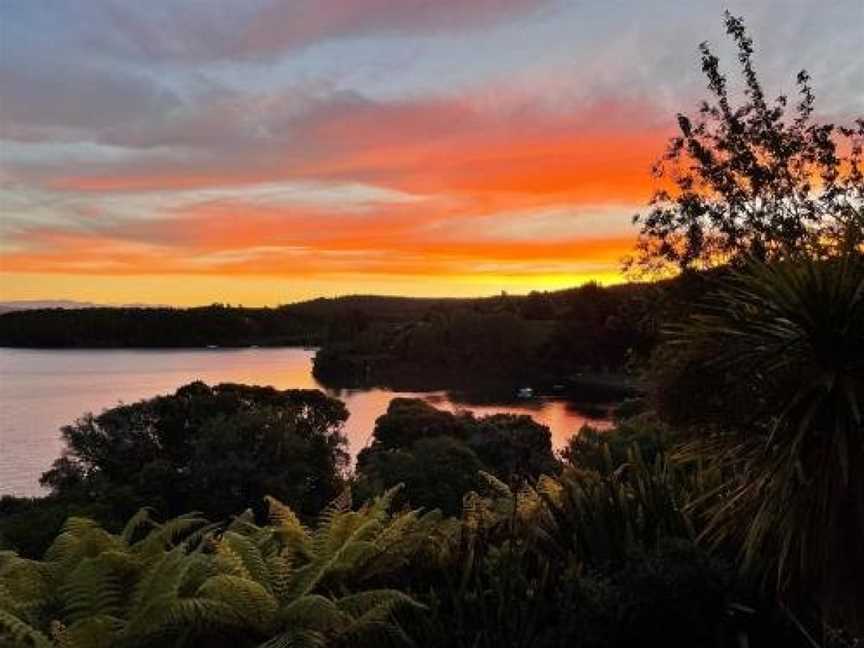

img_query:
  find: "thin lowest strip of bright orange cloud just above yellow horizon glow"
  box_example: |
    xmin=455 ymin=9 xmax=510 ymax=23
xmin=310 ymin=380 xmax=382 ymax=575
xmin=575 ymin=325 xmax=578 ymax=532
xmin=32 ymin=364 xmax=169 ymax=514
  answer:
xmin=0 ymin=236 xmax=632 ymax=279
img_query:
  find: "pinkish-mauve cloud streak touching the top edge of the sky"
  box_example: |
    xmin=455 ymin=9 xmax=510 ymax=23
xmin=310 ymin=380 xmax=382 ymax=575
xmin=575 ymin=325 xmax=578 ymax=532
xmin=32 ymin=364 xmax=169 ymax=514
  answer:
xmin=87 ymin=0 xmax=552 ymax=62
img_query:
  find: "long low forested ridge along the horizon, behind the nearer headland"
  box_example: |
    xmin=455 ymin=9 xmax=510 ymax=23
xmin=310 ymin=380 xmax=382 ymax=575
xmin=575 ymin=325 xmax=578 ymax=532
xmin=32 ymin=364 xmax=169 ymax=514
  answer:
xmin=0 ymin=285 xmax=640 ymax=348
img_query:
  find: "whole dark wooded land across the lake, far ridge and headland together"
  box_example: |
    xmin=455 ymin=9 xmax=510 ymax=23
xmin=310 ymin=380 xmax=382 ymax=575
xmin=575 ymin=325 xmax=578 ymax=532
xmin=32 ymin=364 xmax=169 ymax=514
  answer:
xmin=0 ymin=280 xmax=660 ymax=399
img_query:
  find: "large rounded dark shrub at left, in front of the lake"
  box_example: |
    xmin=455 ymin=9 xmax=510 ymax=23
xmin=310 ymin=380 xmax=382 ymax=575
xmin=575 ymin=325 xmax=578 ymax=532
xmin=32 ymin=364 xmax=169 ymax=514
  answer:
xmin=42 ymin=382 xmax=348 ymax=520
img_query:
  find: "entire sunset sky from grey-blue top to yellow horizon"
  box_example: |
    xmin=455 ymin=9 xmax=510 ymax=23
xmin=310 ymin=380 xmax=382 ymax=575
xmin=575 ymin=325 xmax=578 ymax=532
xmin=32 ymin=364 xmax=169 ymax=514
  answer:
xmin=0 ymin=0 xmax=864 ymax=305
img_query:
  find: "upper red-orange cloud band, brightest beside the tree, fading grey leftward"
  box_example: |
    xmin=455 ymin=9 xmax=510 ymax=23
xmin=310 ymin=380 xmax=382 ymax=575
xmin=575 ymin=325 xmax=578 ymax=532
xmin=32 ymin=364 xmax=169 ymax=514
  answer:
xmin=47 ymin=91 xmax=669 ymax=203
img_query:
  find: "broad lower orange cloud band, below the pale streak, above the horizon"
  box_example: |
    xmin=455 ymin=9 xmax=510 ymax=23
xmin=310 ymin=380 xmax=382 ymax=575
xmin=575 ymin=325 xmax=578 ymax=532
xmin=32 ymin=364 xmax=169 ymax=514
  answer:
xmin=0 ymin=194 xmax=632 ymax=277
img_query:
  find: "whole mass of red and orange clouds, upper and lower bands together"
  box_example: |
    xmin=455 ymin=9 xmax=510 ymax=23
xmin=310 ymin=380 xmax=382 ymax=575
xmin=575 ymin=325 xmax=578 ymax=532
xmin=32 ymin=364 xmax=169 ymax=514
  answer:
xmin=0 ymin=90 xmax=666 ymax=298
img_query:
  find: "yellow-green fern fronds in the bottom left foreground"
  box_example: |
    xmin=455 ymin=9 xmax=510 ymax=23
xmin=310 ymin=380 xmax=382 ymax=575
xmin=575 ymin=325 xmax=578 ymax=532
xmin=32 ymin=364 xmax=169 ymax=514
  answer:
xmin=0 ymin=492 xmax=439 ymax=648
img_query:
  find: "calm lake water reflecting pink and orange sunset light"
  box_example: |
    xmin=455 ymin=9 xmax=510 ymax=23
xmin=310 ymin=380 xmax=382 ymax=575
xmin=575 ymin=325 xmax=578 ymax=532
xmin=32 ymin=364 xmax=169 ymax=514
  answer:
xmin=0 ymin=349 xmax=608 ymax=495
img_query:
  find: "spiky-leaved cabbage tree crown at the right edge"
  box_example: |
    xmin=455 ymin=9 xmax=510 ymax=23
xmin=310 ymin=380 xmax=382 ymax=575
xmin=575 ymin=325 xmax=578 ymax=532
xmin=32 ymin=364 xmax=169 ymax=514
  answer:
xmin=659 ymin=254 xmax=864 ymax=630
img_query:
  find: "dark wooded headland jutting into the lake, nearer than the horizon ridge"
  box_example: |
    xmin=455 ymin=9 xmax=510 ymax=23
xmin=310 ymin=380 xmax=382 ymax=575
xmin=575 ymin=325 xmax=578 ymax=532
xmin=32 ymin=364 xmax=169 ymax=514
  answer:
xmin=314 ymin=271 xmax=722 ymax=394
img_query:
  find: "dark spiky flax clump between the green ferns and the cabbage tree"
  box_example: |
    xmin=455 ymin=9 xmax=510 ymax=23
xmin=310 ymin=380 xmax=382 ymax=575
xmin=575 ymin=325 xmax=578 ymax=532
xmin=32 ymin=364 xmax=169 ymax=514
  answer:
xmin=412 ymin=448 xmax=731 ymax=648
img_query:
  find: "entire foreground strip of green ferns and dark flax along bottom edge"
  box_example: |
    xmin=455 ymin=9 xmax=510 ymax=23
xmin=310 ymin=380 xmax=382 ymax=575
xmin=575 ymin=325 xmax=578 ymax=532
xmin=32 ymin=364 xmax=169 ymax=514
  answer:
xmin=0 ymin=446 xmax=748 ymax=648
